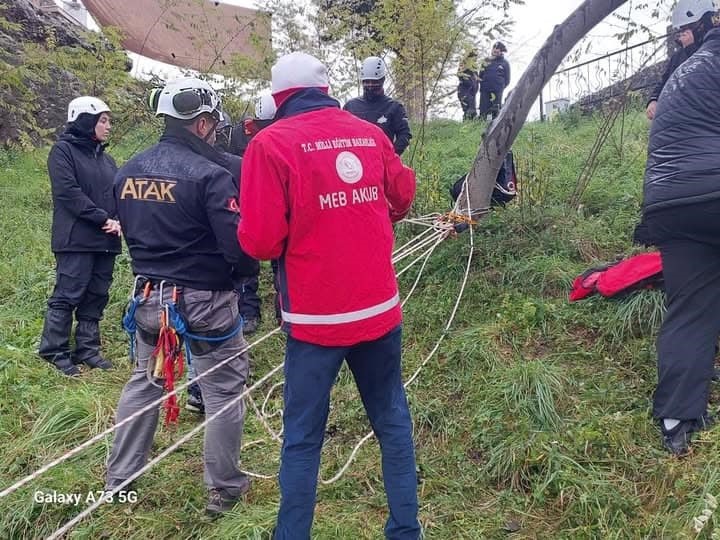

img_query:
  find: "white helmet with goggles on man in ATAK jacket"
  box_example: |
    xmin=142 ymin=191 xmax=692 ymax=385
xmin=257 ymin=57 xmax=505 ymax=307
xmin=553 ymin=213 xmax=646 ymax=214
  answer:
xmin=155 ymin=77 xmax=222 ymax=121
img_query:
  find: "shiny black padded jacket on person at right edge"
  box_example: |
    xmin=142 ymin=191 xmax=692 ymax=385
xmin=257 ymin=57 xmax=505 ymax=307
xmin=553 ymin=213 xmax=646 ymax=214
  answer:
xmin=643 ymin=28 xmax=720 ymax=213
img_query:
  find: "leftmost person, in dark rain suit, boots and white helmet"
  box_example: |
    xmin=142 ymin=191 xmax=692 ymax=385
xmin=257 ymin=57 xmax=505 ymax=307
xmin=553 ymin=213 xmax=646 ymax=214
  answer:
xmin=38 ymin=96 xmax=121 ymax=376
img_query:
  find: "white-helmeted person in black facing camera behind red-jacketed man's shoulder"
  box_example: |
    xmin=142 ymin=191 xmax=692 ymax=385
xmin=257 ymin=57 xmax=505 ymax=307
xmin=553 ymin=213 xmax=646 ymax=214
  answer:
xmin=343 ymin=56 xmax=412 ymax=156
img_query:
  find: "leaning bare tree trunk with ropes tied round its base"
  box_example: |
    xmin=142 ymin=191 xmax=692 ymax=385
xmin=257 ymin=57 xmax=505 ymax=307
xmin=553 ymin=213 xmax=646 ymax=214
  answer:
xmin=458 ymin=0 xmax=626 ymax=217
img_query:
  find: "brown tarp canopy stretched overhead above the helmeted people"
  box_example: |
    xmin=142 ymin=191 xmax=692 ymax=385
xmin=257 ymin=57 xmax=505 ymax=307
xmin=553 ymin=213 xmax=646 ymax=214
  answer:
xmin=83 ymin=0 xmax=271 ymax=73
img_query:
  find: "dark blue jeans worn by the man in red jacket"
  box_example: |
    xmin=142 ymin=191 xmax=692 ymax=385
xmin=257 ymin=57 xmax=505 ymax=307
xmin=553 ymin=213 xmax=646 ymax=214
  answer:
xmin=274 ymin=326 xmax=420 ymax=540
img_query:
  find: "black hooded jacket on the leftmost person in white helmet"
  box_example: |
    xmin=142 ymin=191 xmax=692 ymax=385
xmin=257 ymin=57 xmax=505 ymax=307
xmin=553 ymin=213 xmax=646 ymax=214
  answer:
xmin=47 ymin=130 xmax=121 ymax=253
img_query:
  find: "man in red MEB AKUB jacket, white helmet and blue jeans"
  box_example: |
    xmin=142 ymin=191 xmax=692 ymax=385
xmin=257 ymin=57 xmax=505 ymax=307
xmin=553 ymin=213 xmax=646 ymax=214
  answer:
xmin=238 ymin=53 xmax=420 ymax=539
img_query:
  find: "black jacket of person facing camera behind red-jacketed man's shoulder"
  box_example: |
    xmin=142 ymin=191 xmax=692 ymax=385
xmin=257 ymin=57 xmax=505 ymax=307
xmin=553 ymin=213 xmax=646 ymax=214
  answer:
xmin=343 ymin=95 xmax=412 ymax=155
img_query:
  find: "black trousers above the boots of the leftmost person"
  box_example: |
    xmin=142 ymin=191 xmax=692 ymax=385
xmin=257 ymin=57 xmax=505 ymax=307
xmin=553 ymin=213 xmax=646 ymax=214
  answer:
xmin=48 ymin=252 xmax=115 ymax=321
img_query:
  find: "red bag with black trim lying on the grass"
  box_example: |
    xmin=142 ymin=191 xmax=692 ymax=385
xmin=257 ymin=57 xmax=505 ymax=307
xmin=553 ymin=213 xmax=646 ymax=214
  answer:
xmin=570 ymin=251 xmax=663 ymax=302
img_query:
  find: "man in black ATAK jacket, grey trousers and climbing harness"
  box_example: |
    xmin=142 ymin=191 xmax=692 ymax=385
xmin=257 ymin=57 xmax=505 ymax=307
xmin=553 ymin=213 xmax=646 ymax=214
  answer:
xmin=106 ymin=78 xmax=257 ymax=515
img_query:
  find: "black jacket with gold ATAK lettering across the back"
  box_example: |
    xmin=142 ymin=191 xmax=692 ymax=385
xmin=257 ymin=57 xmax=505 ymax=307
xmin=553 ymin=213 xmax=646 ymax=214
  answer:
xmin=115 ymin=128 xmax=258 ymax=290
